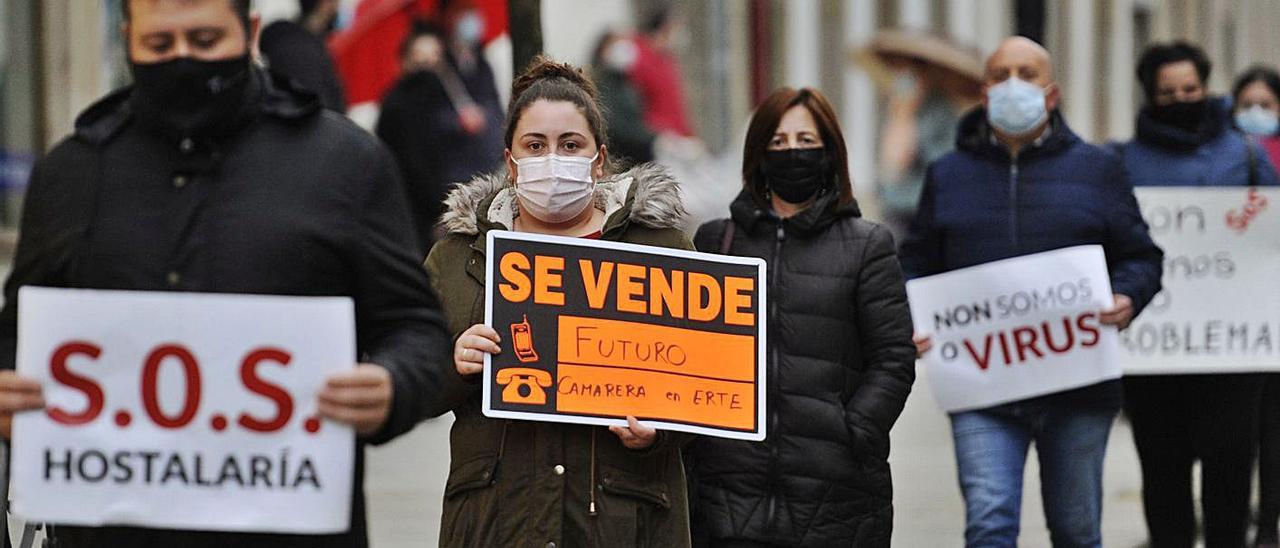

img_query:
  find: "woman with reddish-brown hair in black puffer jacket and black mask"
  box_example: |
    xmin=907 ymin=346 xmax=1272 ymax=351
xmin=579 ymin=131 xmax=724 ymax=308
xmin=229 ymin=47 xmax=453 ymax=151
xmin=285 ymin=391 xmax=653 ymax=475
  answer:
xmin=686 ymin=88 xmax=915 ymax=548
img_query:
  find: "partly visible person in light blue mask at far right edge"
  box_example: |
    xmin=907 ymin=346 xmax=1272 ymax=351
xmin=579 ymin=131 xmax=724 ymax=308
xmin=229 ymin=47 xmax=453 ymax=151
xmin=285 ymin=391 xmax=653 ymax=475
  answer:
xmin=1231 ymin=67 xmax=1280 ymax=548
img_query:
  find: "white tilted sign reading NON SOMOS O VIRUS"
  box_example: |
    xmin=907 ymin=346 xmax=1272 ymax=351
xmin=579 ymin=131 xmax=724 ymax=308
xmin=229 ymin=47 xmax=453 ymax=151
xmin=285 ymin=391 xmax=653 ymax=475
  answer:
xmin=906 ymin=246 xmax=1120 ymax=411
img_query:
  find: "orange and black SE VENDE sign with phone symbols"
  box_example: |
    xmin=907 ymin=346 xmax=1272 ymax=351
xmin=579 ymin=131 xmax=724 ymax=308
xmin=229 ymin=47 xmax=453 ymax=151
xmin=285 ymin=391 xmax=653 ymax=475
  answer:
xmin=483 ymin=230 xmax=767 ymax=440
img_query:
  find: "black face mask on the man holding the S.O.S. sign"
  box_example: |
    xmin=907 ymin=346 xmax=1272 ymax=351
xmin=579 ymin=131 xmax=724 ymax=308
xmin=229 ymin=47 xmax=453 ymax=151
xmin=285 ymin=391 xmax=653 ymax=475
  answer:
xmin=129 ymin=54 xmax=250 ymax=138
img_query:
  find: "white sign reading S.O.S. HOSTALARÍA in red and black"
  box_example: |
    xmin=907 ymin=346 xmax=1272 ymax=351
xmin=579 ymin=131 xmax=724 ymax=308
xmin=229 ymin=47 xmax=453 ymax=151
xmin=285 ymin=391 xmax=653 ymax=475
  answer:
xmin=10 ymin=287 xmax=356 ymax=534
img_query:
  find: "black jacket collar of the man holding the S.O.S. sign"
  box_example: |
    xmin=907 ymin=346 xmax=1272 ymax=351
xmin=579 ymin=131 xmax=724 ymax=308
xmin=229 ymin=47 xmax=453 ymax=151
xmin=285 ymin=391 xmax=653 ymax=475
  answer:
xmin=74 ymin=68 xmax=321 ymax=145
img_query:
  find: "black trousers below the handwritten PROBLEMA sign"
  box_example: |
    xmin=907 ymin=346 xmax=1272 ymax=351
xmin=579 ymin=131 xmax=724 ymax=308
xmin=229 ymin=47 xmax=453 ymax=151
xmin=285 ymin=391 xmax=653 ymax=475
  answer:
xmin=1124 ymin=374 xmax=1262 ymax=548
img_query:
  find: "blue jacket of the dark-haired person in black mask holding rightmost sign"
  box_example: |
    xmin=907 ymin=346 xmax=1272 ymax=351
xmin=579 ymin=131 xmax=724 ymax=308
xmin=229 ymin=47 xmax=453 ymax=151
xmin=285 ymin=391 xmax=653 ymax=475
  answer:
xmin=1115 ymin=97 xmax=1280 ymax=187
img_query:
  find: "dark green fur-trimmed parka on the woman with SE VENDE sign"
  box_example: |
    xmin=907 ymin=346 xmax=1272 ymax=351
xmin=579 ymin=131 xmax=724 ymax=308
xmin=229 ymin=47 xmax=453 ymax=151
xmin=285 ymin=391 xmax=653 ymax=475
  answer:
xmin=426 ymin=164 xmax=692 ymax=548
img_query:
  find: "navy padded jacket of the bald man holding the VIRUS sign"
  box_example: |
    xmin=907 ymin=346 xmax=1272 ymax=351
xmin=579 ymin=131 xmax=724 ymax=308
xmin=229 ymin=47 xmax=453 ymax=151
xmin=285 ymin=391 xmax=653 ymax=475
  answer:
xmin=899 ymin=108 xmax=1164 ymax=406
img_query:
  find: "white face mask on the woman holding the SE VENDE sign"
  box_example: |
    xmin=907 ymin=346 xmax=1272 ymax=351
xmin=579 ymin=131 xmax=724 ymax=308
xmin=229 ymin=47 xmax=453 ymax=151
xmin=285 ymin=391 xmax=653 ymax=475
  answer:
xmin=515 ymin=152 xmax=600 ymax=224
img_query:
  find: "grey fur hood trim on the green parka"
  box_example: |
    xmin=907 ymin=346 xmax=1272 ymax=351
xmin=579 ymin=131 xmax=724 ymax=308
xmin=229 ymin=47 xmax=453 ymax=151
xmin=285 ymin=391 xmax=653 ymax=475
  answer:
xmin=440 ymin=164 xmax=686 ymax=236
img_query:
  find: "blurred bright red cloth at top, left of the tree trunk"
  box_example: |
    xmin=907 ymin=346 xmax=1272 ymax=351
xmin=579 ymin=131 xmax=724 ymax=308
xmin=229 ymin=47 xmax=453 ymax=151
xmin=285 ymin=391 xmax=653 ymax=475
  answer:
xmin=329 ymin=0 xmax=507 ymax=105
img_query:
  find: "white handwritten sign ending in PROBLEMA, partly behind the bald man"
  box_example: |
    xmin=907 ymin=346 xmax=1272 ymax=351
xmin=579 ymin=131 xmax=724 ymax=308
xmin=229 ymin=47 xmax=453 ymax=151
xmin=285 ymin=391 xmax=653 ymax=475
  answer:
xmin=1121 ymin=187 xmax=1280 ymax=375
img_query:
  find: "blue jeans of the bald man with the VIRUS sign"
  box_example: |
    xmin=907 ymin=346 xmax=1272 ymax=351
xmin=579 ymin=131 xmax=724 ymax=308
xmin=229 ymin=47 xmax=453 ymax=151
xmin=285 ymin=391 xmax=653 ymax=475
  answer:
xmin=951 ymin=399 xmax=1119 ymax=548
